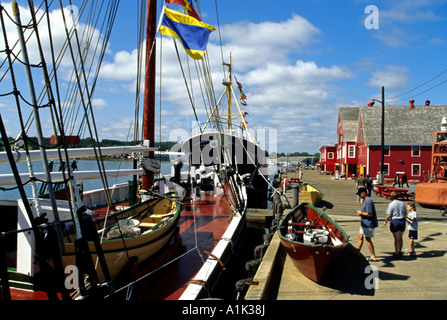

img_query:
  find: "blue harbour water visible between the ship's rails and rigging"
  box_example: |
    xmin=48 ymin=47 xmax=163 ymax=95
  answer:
xmin=0 ymin=160 xmax=175 ymax=200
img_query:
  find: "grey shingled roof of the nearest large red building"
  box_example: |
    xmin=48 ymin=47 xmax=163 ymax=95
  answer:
xmin=360 ymin=106 xmax=447 ymax=145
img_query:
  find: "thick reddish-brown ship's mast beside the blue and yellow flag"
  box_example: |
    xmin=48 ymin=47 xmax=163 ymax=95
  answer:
xmin=143 ymin=0 xmax=157 ymax=190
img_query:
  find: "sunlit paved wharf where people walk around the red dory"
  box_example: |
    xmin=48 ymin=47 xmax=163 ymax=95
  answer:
xmin=245 ymin=170 xmax=447 ymax=300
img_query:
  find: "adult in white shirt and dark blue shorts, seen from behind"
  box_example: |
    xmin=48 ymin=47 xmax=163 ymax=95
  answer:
xmin=384 ymin=191 xmax=407 ymax=258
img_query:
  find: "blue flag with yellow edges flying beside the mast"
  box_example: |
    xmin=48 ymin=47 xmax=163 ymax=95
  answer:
xmin=159 ymin=8 xmax=216 ymax=60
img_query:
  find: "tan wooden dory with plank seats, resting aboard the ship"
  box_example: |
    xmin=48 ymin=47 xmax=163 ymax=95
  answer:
xmin=62 ymin=193 xmax=181 ymax=280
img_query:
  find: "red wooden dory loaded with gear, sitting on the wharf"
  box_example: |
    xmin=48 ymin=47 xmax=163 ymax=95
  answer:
xmin=278 ymin=203 xmax=348 ymax=282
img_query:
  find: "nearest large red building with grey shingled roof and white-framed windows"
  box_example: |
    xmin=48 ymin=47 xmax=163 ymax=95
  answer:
xmin=356 ymin=105 xmax=447 ymax=183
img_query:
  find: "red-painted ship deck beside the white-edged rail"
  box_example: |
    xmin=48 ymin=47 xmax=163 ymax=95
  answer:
xmin=125 ymin=192 xmax=231 ymax=300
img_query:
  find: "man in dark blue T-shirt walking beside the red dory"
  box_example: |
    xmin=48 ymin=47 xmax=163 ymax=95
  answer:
xmin=357 ymin=187 xmax=378 ymax=261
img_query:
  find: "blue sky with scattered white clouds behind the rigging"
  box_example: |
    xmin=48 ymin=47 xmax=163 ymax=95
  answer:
xmin=0 ymin=0 xmax=447 ymax=154
